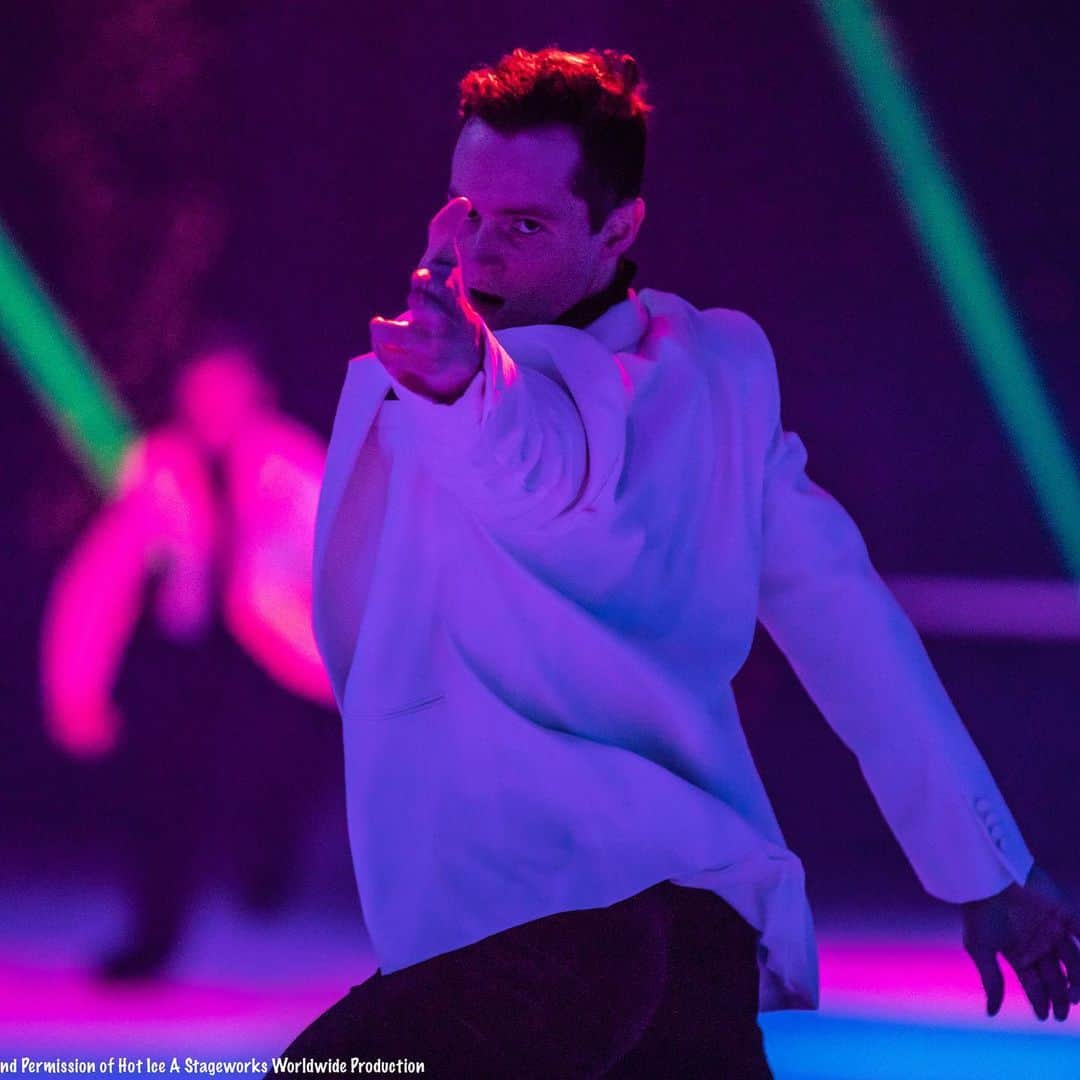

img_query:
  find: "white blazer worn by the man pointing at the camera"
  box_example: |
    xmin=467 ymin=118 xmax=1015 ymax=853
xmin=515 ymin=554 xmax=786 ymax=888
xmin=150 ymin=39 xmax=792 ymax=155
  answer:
xmin=314 ymin=289 xmax=1032 ymax=1011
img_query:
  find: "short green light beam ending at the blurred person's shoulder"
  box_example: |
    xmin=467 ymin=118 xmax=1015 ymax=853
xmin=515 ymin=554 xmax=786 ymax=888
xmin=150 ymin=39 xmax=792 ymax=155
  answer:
xmin=0 ymin=222 xmax=136 ymax=490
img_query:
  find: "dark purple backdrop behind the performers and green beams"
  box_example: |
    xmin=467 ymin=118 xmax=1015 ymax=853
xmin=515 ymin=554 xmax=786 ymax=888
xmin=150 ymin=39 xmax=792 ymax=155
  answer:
xmin=0 ymin=0 xmax=1080 ymax=937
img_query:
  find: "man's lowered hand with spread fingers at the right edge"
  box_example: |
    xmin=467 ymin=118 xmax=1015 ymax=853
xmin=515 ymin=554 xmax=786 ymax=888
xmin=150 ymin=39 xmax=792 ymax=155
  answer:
xmin=960 ymin=866 xmax=1080 ymax=1020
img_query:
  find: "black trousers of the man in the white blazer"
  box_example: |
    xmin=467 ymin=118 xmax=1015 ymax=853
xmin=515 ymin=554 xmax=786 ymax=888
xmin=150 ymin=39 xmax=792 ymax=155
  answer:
xmin=274 ymin=881 xmax=772 ymax=1080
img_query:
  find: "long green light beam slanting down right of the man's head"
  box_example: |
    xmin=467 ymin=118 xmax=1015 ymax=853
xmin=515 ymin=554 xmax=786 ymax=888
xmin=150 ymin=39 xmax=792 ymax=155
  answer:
xmin=818 ymin=0 xmax=1080 ymax=578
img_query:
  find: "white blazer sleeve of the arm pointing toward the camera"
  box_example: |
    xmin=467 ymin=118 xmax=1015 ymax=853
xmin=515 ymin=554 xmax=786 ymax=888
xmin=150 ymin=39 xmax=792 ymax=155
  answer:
xmin=391 ymin=326 xmax=626 ymax=531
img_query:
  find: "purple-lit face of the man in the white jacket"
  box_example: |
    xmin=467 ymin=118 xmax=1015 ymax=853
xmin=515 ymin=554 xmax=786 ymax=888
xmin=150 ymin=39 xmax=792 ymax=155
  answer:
xmin=449 ymin=118 xmax=615 ymax=329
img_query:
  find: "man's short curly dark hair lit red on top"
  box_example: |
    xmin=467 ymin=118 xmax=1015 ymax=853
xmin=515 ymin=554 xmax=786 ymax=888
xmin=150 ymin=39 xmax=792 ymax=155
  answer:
xmin=459 ymin=45 xmax=652 ymax=232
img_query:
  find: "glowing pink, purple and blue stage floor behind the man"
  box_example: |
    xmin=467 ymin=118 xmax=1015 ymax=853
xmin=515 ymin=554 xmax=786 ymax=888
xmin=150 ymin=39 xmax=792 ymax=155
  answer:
xmin=0 ymin=885 xmax=1080 ymax=1080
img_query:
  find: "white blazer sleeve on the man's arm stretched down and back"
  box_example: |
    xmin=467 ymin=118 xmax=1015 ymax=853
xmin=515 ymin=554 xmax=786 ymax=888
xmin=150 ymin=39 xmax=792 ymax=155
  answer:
xmin=754 ymin=315 xmax=1032 ymax=903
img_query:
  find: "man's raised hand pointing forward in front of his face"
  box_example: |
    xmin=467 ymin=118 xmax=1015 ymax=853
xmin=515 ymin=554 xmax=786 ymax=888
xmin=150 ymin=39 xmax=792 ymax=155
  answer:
xmin=369 ymin=198 xmax=484 ymax=402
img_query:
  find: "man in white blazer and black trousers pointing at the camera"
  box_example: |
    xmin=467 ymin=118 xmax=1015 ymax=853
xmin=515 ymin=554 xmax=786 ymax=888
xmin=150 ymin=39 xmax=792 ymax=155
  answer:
xmin=287 ymin=49 xmax=1080 ymax=1077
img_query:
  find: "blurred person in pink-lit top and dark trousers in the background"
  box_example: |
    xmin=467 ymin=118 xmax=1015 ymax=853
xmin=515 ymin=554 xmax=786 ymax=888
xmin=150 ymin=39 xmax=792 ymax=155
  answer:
xmin=41 ymin=336 xmax=333 ymax=978
